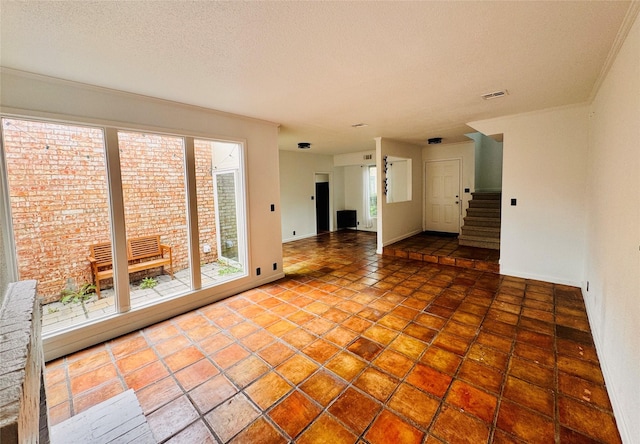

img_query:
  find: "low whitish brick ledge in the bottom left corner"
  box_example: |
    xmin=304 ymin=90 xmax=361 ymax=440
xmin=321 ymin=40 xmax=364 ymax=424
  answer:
xmin=0 ymin=281 xmax=49 ymax=444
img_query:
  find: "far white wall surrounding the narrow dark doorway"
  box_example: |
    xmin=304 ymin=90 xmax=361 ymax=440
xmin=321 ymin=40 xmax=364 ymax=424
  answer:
xmin=280 ymin=151 xmax=337 ymax=242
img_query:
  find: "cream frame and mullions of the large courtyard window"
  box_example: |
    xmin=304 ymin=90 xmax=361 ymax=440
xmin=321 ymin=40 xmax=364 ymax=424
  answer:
xmin=0 ymin=112 xmax=254 ymax=358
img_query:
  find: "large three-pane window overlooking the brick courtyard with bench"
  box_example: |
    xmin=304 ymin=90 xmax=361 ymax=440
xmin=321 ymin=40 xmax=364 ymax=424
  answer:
xmin=0 ymin=118 xmax=248 ymax=334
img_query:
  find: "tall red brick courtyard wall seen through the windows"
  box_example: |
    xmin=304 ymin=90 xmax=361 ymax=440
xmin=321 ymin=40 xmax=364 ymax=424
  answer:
xmin=3 ymin=119 xmax=217 ymax=302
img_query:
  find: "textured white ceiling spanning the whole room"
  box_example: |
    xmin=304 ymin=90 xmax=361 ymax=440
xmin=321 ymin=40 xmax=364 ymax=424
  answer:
xmin=0 ymin=0 xmax=631 ymax=154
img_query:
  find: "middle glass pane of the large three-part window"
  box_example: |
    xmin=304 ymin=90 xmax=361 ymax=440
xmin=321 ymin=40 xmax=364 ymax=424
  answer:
xmin=118 ymin=131 xmax=191 ymax=307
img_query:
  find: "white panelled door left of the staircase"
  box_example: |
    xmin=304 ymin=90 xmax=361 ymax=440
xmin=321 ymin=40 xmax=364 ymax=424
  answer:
xmin=424 ymin=159 xmax=462 ymax=233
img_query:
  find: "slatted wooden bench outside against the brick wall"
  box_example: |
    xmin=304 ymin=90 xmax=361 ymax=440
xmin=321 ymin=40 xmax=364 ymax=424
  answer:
xmin=87 ymin=236 xmax=173 ymax=299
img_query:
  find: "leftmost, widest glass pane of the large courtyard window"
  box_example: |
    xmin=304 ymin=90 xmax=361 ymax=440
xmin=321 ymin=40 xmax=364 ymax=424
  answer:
xmin=2 ymin=119 xmax=115 ymax=333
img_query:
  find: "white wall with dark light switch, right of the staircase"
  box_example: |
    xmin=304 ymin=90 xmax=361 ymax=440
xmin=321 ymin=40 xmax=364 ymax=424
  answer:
xmin=470 ymin=106 xmax=589 ymax=286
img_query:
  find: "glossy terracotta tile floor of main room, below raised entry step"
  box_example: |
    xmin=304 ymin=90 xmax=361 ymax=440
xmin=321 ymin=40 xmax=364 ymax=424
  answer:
xmin=46 ymin=231 xmax=620 ymax=444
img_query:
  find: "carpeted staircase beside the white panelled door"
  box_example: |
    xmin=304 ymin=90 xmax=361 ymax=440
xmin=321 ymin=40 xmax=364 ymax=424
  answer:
xmin=458 ymin=193 xmax=502 ymax=250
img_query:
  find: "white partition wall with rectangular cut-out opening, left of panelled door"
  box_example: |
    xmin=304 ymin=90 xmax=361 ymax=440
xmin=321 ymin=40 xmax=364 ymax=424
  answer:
xmin=376 ymin=137 xmax=423 ymax=253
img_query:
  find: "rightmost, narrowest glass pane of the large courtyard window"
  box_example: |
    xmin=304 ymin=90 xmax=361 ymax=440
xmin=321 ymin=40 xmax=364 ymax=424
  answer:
xmin=194 ymin=139 xmax=246 ymax=287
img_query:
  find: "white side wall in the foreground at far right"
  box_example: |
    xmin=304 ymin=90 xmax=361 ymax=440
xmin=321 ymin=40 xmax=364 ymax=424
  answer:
xmin=583 ymin=14 xmax=640 ymax=443
